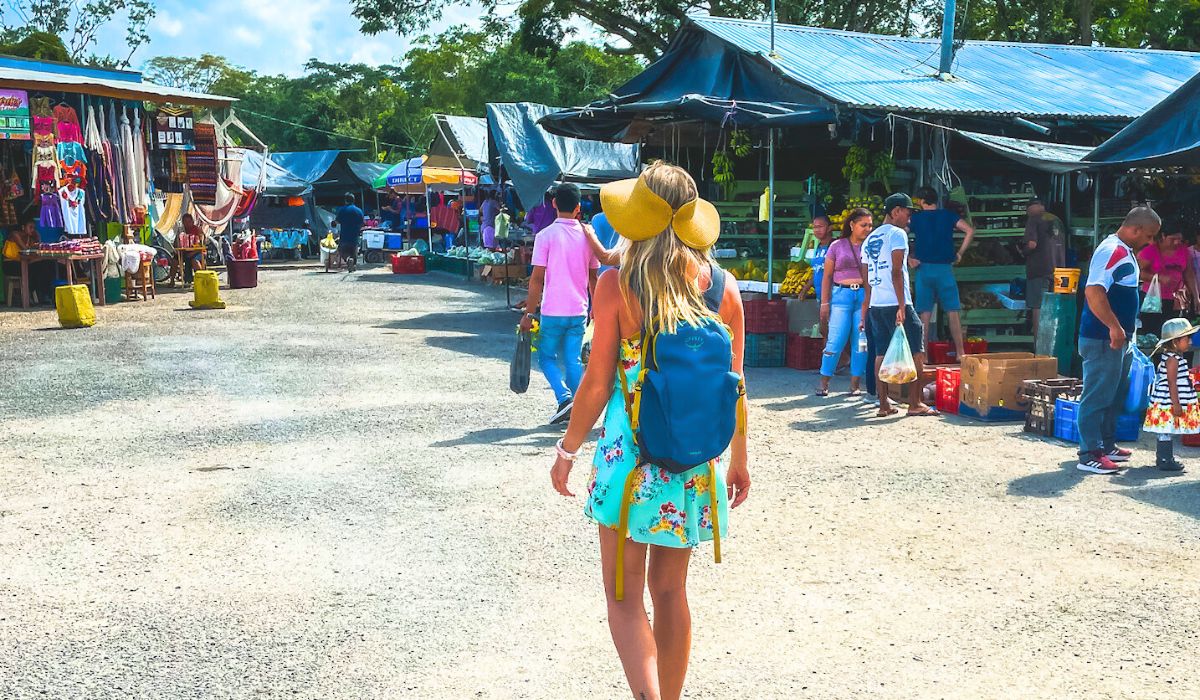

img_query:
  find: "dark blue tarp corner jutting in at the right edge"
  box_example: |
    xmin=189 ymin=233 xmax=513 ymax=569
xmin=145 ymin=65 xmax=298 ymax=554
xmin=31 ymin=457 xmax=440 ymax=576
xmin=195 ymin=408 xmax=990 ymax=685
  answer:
xmin=1087 ymin=70 xmax=1200 ymax=167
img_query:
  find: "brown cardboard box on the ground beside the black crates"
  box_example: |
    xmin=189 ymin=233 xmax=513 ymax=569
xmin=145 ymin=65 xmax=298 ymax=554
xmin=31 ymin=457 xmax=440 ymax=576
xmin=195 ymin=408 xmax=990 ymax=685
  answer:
xmin=959 ymin=353 xmax=1058 ymax=420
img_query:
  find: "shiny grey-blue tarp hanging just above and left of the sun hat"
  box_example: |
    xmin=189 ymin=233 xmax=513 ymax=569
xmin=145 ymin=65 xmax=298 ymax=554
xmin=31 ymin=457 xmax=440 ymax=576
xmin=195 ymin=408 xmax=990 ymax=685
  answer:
xmin=487 ymin=102 xmax=641 ymax=209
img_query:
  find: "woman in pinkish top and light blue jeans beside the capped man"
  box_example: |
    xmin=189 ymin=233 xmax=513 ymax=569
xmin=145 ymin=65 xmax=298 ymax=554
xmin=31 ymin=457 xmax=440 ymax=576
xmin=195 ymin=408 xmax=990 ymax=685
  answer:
xmin=817 ymin=209 xmax=874 ymax=396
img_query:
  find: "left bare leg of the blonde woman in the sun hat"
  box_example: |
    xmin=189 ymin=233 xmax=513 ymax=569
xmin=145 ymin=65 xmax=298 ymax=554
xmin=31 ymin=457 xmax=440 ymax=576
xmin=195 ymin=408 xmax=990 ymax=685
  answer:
xmin=600 ymin=526 xmax=678 ymax=700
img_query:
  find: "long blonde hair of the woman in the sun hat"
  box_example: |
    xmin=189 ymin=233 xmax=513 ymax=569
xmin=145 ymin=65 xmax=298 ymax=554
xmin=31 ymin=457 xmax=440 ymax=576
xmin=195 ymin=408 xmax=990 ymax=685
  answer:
xmin=620 ymin=161 xmax=715 ymax=333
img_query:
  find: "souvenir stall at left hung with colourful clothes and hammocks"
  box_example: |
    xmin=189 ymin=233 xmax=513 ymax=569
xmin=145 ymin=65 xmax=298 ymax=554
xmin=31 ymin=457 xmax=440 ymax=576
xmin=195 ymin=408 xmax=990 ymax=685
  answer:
xmin=0 ymin=61 xmax=237 ymax=307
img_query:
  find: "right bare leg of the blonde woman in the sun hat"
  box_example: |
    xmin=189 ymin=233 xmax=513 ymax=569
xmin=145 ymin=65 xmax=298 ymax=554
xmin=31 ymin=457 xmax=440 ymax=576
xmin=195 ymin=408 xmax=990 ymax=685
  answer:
xmin=648 ymin=546 xmax=691 ymax=700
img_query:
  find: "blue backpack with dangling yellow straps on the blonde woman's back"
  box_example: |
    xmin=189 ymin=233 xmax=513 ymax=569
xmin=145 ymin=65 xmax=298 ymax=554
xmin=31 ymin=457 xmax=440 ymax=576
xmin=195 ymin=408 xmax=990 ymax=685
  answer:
xmin=616 ymin=265 xmax=745 ymax=600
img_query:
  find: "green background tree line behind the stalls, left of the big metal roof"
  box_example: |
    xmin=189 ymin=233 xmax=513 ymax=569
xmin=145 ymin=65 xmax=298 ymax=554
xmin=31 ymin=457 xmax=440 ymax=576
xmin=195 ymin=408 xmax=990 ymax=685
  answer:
xmin=145 ymin=20 xmax=642 ymax=160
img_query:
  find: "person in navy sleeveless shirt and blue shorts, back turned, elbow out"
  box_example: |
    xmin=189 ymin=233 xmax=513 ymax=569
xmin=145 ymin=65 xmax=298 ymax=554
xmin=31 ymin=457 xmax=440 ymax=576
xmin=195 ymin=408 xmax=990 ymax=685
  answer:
xmin=908 ymin=187 xmax=974 ymax=360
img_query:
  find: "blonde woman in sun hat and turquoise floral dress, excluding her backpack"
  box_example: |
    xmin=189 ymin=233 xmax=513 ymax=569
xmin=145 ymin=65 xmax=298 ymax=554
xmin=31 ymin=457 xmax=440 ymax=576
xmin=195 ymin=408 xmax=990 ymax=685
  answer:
xmin=551 ymin=163 xmax=750 ymax=700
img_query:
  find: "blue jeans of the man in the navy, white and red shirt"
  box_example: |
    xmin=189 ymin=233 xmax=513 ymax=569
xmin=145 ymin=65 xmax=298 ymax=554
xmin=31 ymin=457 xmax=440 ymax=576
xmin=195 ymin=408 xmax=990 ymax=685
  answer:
xmin=1078 ymin=337 xmax=1133 ymax=456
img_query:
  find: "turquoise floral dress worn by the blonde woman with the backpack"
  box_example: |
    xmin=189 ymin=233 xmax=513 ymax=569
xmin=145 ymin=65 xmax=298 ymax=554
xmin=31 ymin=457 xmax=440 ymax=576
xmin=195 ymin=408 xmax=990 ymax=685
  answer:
xmin=583 ymin=337 xmax=728 ymax=548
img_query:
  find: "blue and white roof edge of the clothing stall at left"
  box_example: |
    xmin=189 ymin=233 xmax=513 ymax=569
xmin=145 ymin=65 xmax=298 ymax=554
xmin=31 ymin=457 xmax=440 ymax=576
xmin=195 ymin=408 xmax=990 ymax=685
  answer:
xmin=0 ymin=58 xmax=236 ymax=107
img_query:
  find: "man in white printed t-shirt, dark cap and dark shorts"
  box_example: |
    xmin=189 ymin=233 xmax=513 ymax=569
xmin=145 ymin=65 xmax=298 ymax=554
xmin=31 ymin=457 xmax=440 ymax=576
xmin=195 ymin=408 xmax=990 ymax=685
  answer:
xmin=862 ymin=193 xmax=938 ymax=417
